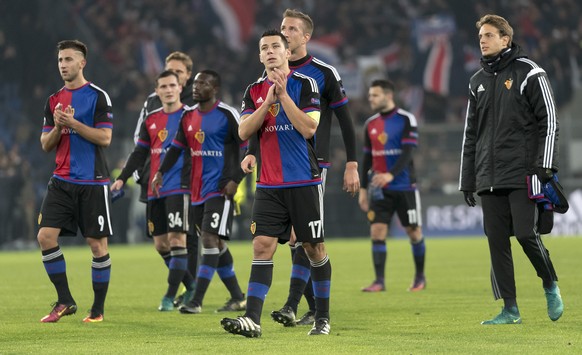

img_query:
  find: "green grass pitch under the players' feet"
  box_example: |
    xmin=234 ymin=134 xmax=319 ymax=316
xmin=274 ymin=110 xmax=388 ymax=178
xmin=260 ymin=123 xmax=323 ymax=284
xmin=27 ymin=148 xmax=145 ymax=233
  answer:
xmin=0 ymin=237 xmax=582 ymax=354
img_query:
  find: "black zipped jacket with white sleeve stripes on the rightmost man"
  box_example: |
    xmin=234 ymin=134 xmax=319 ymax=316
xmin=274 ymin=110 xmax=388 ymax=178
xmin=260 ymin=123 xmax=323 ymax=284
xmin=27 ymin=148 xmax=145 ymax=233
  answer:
xmin=459 ymin=44 xmax=559 ymax=194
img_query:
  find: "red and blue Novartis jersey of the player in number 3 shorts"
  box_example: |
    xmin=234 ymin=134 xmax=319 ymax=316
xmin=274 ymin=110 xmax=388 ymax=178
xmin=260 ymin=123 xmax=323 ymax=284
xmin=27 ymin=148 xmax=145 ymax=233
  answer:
xmin=172 ymin=101 xmax=243 ymax=205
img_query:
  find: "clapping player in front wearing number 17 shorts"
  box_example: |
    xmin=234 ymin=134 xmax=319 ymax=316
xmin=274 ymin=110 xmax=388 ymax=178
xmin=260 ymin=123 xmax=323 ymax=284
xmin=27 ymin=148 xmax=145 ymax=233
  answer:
xmin=221 ymin=30 xmax=331 ymax=337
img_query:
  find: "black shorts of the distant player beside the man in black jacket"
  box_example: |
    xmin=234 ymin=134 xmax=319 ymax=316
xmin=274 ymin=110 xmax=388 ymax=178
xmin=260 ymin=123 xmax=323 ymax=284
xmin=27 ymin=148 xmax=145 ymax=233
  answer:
xmin=367 ymin=190 xmax=422 ymax=227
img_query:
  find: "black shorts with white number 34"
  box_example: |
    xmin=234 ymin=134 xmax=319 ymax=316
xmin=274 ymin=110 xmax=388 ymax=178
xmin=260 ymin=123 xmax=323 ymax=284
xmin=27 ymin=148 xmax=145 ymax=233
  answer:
xmin=146 ymin=194 xmax=190 ymax=237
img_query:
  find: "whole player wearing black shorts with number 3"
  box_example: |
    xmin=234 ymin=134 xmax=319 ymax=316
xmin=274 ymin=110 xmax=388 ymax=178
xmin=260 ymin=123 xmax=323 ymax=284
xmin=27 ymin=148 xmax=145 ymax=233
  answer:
xmin=153 ymin=70 xmax=246 ymax=314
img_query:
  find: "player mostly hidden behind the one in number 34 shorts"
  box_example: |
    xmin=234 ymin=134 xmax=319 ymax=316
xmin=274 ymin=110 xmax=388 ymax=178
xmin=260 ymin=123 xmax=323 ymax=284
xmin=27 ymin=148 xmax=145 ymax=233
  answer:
xmin=133 ymin=51 xmax=198 ymax=306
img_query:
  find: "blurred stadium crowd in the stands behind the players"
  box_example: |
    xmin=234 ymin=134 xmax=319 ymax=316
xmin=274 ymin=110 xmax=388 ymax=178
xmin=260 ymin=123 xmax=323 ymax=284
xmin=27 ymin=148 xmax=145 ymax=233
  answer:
xmin=0 ymin=0 xmax=582 ymax=246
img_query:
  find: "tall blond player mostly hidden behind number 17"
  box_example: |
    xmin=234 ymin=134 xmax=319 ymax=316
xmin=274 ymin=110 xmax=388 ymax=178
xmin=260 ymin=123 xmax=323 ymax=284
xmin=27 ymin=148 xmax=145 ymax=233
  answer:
xmin=241 ymin=9 xmax=360 ymax=326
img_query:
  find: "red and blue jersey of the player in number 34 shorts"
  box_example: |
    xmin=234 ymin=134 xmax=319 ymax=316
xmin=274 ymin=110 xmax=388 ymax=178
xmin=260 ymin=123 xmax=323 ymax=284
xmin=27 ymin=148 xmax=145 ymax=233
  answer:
xmin=136 ymin=105 xmax=190 ymax=200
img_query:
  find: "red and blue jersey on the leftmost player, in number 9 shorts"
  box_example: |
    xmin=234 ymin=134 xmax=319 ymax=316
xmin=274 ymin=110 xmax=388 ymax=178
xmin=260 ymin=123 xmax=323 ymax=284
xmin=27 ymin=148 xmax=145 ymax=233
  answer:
xmin=42 ymin=83 xmax=113 ymax=185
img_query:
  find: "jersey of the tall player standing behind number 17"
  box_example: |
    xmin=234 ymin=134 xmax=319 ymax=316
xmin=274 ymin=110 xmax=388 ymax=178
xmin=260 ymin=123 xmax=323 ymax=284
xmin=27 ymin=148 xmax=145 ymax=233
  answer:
xmin=289 ymin=55 xmax=355 ymax=168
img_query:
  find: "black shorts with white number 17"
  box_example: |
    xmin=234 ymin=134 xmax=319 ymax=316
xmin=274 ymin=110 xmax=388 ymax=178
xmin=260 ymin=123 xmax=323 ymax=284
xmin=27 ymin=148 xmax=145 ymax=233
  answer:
xmin=251 ymin=185 xmax=324 ymax=243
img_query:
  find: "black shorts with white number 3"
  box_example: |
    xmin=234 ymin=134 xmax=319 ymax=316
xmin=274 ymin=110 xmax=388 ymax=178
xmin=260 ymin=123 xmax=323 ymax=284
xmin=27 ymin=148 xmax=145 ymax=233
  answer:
xmin=190 ymin=196 xmax=234 ymax=240
